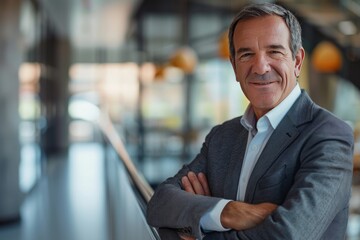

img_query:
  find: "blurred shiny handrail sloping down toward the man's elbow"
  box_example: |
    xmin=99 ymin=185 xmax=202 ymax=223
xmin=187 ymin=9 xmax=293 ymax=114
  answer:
xmin=99 ymin=112 xmax=154 ymax=202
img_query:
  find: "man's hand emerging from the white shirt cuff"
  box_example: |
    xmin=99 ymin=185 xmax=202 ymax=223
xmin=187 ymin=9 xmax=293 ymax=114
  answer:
xmin=220 ymin=201 xmax=278 ymax=231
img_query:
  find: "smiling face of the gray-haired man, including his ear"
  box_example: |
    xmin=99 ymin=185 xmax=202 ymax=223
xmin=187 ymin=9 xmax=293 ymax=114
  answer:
xmin=231 ymin=16 xmax=305 ymax=119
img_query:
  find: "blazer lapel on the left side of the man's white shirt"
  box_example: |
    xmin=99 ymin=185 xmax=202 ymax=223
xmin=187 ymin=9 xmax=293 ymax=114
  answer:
xmin=224 ymin=126 xmax=248 ymax=200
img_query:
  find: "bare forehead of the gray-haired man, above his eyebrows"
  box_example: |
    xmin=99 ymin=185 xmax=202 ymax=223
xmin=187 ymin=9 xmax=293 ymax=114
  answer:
xmin=234 ymin=15 xmax=290 ymax=48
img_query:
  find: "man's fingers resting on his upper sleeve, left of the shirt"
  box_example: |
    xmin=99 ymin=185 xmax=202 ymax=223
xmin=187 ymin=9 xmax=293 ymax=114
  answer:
xmin=181 ymin=171 xmax=211 ymax=196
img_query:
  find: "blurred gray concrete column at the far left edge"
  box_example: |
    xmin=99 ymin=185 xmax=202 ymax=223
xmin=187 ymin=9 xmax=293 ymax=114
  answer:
xmin=0 ymin=0 xmax=22 ymax=225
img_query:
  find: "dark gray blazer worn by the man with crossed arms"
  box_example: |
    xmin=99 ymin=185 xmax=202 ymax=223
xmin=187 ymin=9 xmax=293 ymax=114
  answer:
xmin=147 ymin=91 xmax=354 ymax=240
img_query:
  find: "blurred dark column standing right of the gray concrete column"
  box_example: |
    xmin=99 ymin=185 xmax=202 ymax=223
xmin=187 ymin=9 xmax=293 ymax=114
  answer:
xmin=39 ymin=16 xmax=70 ymax=155
